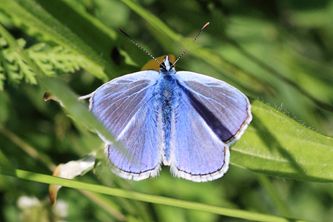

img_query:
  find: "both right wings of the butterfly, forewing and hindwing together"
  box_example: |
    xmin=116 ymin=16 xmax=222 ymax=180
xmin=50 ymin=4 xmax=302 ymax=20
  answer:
xmin=170 ymin=72 xmax=252 ymax=182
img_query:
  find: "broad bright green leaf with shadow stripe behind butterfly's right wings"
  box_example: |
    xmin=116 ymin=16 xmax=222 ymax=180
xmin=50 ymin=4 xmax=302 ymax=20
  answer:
xmin=231 ymin=101 xmax=333 ymax=182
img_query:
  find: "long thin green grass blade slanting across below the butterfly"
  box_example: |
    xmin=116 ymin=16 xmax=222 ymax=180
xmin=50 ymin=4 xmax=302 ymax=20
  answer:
xmin=0 ymin=168 xmax=302 ymax=222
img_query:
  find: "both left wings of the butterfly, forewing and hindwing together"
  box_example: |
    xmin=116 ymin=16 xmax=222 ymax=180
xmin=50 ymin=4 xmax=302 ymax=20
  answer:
xmin=90 ymin=71 xmax=162 ymax=180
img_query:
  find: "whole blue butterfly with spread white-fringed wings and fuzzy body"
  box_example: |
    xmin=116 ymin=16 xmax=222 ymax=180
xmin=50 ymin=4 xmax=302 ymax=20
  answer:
xmin=90 ymin=56 xmax=252 ymax=182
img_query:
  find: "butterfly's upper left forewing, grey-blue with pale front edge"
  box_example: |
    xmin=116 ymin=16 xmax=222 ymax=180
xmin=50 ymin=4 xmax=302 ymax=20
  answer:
xmin=90 ymin=71 xmax=159 ymax=139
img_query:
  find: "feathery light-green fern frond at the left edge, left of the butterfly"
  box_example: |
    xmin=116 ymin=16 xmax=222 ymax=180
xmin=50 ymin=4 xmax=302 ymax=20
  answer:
xmin=0 ymin=37 xmax=84 ymax=90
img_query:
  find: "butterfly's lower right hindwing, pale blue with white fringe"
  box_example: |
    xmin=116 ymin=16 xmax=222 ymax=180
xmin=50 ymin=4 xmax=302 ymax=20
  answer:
xmin=170 ymin=83 xmax=229 ymax=182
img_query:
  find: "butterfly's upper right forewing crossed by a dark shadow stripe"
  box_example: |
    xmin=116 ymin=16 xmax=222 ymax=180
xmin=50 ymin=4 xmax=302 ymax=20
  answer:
xmin=176 ymin=71 xmax=252 ymax=144
